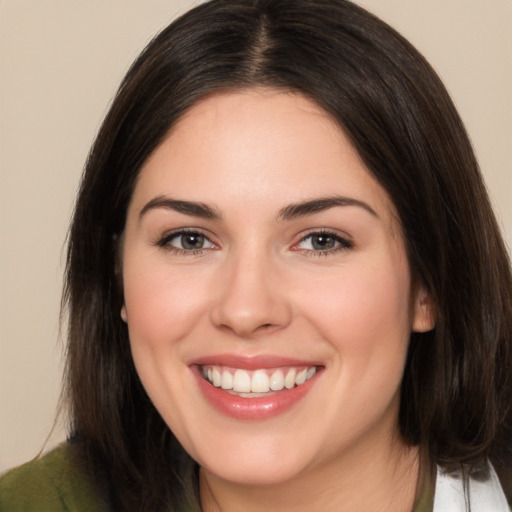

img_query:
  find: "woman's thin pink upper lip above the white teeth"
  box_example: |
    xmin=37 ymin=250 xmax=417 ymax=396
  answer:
xmin=190 ymin=354 xmax=323 ymax=370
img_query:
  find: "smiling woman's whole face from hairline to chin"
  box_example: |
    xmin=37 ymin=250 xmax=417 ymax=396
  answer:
xmin=122 ymin=90 xmax=430 ymax=484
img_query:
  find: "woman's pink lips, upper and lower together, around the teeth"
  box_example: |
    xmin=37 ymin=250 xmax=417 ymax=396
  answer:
xmin=190 ymin=356 xmax=322 ymax=421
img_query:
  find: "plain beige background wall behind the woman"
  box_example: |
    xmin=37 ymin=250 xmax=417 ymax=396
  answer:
xmin=0 ymin=0 xmax=512 ymax=470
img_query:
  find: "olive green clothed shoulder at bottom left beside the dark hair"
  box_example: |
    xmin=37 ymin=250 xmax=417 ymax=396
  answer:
xmin=0 ymin=443 xmax=107 ymax=512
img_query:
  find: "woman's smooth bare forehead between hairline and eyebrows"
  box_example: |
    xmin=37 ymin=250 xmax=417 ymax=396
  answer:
xmin=130 ymin=89 xmax=393 ymax=224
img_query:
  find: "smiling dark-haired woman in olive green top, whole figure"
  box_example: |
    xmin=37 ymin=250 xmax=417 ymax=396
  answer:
xmin=0 ymin=0 xmax=512 ymax=512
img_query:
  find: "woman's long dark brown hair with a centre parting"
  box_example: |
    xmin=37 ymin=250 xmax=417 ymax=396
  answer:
xmin=63 ymin=0 xmax=512 ymax=512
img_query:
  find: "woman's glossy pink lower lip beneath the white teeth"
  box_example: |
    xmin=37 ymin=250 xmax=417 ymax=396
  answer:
xmin=191 ymin=366 xmax=319 ymax=421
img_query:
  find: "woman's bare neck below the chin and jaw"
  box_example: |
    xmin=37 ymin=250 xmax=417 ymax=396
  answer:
xmin=200 ymin=441 xmax=420 ymax=512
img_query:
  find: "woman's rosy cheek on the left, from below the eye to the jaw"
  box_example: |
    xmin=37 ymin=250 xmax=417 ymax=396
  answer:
xmin=123 ymin=251 xmax=201 ymax=437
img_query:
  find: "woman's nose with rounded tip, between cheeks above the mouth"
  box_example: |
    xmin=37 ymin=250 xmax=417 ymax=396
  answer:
xmin=211 ymin=249 xmax=291 ymax=339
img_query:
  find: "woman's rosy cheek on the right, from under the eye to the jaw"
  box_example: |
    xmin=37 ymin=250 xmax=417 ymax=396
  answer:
xmin=307 ymin=266 xmax=410 ymax=431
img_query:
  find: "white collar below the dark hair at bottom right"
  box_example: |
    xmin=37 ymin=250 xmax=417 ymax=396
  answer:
xmin=433 ymin=465 xmax=510 ymax=512
